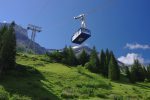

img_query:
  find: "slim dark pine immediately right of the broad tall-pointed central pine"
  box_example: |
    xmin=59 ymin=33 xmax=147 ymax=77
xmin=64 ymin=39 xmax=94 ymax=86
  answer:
xmin=99 ymin=50 xmax=108 ymax=76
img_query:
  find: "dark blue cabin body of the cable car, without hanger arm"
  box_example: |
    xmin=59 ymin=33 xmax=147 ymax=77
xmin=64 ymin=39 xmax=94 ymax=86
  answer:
xmin=72 ymin=28 xmax=91 ymax=44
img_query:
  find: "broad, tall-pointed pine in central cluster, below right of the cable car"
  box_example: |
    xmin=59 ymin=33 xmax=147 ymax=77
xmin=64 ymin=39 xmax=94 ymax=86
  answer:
xmin=86 ymin=47 xmax=99 ymax=73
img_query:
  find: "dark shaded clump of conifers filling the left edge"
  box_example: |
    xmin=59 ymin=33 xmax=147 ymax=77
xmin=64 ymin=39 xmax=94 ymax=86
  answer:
xmin=0 ymin=22 xmax=16 ymax=75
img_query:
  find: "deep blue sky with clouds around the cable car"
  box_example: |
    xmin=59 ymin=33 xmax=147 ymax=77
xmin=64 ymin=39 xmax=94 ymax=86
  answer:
xmin=0 ymin=0 xmax=150 ymax=63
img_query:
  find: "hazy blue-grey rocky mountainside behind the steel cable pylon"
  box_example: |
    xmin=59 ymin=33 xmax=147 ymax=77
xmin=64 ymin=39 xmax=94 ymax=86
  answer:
xmin=0 ymin=23 xmax=47 ymax=54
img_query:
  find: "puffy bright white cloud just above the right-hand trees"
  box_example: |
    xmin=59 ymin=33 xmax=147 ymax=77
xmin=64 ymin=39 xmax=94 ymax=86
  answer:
xmin=118 ymin=53 xmax=144 ymax=65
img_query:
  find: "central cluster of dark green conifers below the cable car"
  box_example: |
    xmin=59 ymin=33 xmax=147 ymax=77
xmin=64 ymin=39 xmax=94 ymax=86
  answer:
xmin=47 ymin=46 xmax=120 ymax=80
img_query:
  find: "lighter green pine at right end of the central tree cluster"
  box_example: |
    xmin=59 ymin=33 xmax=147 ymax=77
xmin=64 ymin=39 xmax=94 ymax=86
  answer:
xmin=108 ymin=52 xmax=120 ymax=80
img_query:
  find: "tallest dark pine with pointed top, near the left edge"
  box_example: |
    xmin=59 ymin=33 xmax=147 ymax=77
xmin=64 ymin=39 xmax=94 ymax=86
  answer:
xmin=1 ymin=22 xmax=16 ymax=70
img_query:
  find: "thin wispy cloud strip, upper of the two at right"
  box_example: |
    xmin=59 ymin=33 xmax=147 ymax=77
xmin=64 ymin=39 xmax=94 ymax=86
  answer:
xmin=125 ymin=43 xmax=150 ymax=50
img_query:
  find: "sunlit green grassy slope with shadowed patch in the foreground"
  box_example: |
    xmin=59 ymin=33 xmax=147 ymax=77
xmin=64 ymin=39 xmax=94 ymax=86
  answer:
xmin=0 ymin=54 xmax=150 ymax=100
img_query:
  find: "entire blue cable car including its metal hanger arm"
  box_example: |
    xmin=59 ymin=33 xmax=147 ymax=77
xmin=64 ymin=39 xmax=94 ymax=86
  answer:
xmin=72 ymin=14 xmax=91 ymax=44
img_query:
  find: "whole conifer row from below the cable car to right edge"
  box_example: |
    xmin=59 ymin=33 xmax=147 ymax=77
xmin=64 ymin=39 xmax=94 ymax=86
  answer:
xmin=48 ymin=46 xmax=150 ymax=83
